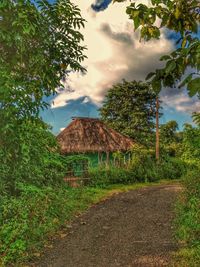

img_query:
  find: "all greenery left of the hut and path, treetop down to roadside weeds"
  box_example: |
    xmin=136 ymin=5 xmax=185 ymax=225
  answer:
xmin=0 ymin=0 xmax=87 ymax=266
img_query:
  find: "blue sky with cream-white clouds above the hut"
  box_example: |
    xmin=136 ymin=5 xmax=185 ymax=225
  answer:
xmin=42 ymin=0 xmax=200 ymax=134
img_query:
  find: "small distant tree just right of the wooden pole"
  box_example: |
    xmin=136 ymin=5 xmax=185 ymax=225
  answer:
xmin=160 ymin=121 xmax=178 ymax=144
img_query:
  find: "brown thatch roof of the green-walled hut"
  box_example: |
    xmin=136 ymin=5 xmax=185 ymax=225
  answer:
xmin=57 ymin=118 xmax=133 ymax=154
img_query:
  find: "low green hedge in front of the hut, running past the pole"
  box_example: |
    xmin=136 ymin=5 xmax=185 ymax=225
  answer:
xmin=89 ymin=149 xmax=185 ymax=188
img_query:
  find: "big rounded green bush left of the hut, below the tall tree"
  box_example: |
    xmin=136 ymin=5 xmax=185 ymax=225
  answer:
xmin=0 ymin=120 xmax=65 ymax=194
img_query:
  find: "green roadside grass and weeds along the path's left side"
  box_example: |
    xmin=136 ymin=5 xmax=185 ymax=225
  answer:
xmin=0 ymin=180 xmax=178 ymax=267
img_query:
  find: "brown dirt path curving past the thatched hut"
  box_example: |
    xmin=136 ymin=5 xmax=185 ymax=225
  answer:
xmin=36 ymin=185 xmax=181 ymax=267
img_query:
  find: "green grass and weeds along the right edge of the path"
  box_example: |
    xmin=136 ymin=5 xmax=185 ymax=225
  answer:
xmin=176 ymin=168 xmax=200 ymax=267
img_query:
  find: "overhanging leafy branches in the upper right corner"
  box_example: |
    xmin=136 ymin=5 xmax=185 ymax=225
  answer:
xmin=113 ymin=0 xmax=200 ymax=96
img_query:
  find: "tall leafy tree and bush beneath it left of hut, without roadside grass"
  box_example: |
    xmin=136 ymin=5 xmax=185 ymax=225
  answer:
xmin=0 ymin=0 xmax=85 ymax=187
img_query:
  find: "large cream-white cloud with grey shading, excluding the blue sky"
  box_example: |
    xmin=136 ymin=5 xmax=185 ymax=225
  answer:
xmin=52 ymin=0 xmax=195 ymax=111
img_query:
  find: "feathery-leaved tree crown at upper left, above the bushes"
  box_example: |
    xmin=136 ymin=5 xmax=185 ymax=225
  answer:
xmin=0 ymin=0 xmax=84 ymax=120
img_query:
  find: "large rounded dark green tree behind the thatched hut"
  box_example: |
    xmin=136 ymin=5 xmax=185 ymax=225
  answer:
xmin=100 ymin=80 xmax=159 ymax=145
